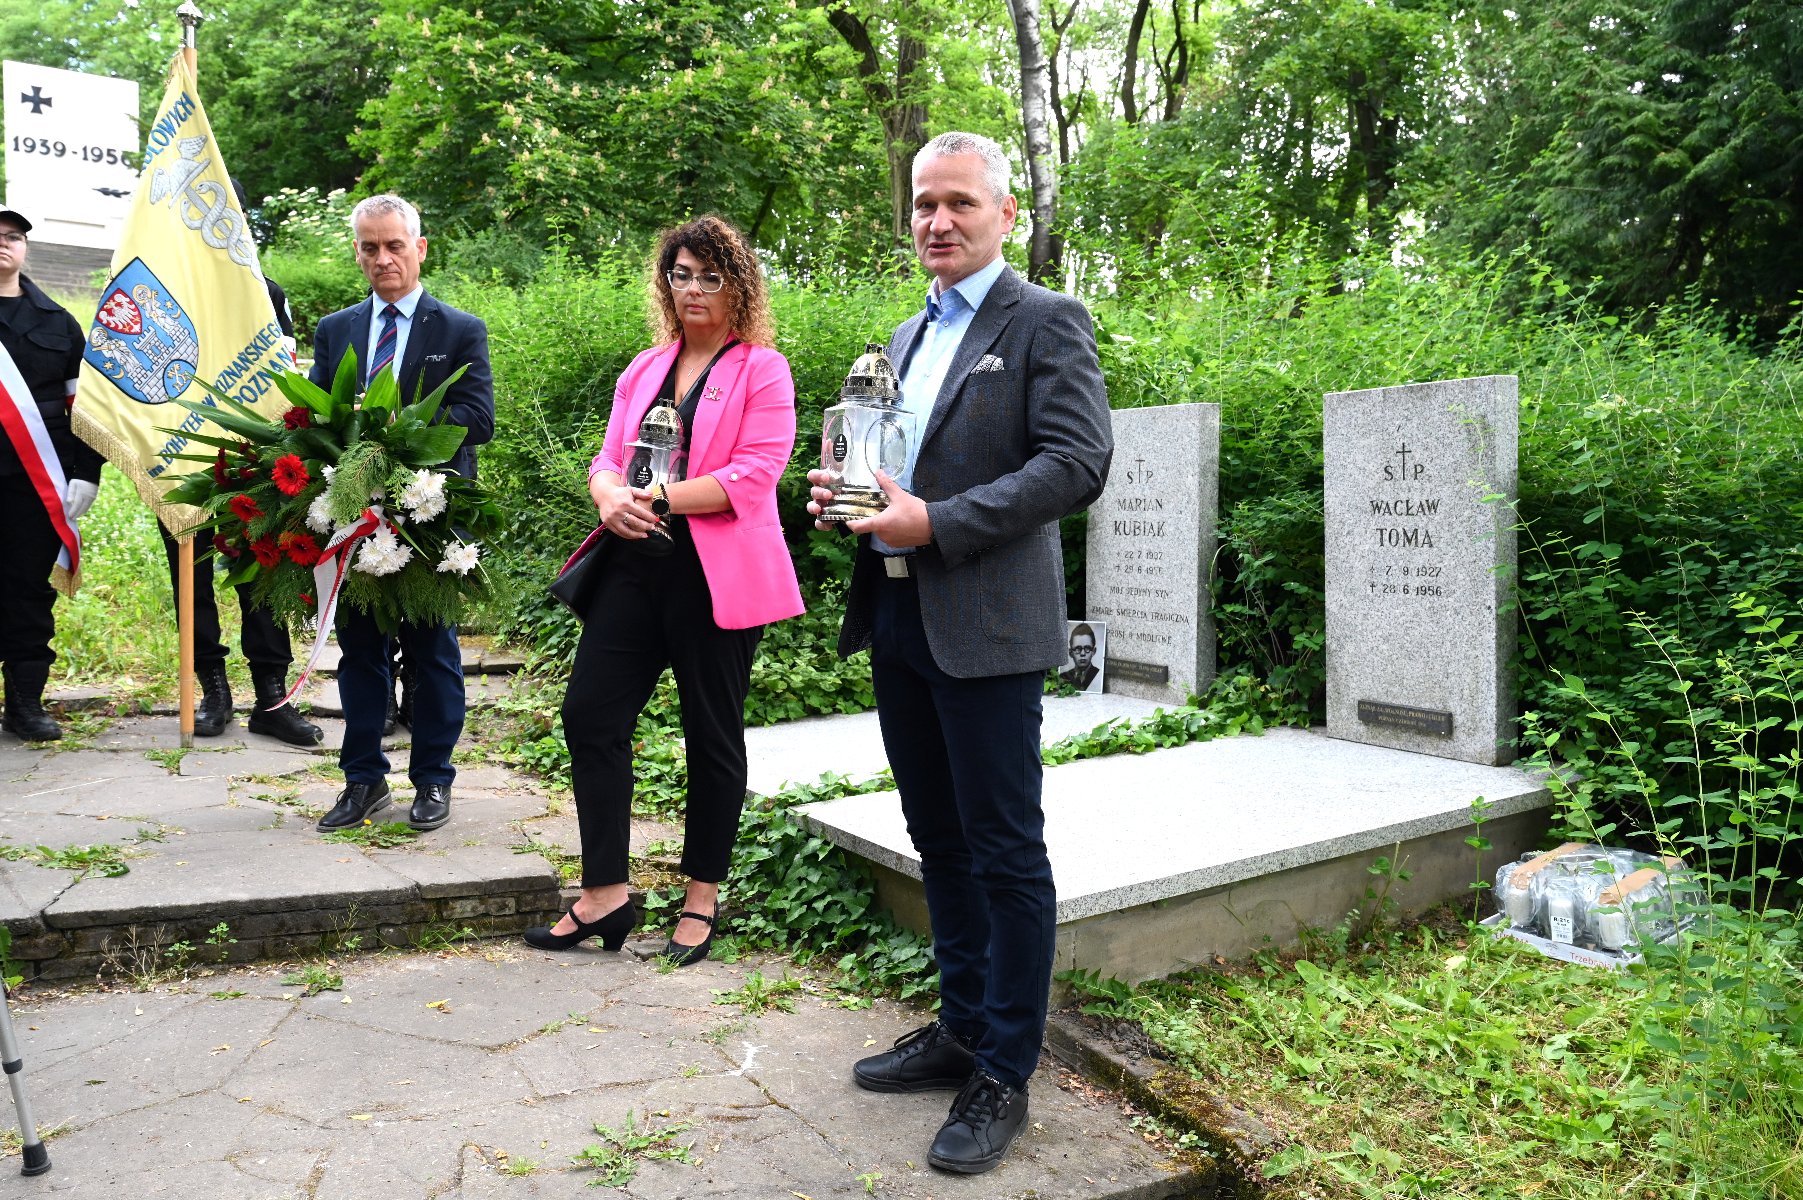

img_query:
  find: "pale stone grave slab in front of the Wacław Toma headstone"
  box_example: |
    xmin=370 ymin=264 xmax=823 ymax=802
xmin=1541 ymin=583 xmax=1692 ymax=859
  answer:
xmin=801 ymin=730 xmax=1552 ymax=982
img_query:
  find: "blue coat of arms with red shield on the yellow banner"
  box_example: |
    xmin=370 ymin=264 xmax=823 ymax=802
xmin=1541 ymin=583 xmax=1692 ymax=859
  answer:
xmin=83 ymin=258 xmax=200 ymax=404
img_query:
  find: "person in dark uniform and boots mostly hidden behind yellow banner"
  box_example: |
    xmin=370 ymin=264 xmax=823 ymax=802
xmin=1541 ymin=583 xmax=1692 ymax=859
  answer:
xmin=159 ymin=178 xmax=325 ymax=746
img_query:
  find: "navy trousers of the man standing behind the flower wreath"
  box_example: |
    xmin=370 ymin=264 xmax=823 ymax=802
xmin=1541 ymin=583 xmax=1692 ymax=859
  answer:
xmin=337 ymin=607 xmax=463 ymax=787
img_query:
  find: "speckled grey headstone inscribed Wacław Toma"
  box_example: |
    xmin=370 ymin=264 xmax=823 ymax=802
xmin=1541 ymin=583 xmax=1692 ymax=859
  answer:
xmin=1323 ymin=375 xmax=1520 ymax=766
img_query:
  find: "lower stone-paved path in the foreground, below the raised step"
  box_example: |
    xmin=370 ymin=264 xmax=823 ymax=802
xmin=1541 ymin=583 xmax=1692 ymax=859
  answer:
xmin=14 ymin=942 xmax=1213 ymax=1200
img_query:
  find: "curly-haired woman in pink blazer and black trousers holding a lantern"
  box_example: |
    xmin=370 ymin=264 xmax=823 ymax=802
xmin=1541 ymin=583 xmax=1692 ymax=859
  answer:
xmin=526 ymin=216 xmax=802 ymax=966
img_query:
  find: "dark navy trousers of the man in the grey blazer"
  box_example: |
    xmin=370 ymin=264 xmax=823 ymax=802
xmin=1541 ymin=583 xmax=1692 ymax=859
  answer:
xmin=871 ymin=577 xmax=1058 ymax=1086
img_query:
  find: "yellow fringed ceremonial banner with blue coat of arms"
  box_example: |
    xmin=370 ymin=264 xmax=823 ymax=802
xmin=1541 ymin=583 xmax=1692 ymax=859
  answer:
xmin=74 ymin=54 xmax=294 ymax=533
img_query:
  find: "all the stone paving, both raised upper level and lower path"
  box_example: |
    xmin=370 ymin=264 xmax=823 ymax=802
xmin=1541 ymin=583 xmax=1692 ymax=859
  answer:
xmin=0 ymin=702 xmax=1213 ymax=1200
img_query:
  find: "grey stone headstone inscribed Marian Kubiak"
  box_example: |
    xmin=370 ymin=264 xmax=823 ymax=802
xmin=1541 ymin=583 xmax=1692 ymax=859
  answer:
xmin=1084 ymin=404 xmax=1221 ymax=705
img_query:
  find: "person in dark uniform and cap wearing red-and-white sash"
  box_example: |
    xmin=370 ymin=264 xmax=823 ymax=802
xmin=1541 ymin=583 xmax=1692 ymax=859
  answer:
xmin=0 ymin=209 xmax=101 ymax=742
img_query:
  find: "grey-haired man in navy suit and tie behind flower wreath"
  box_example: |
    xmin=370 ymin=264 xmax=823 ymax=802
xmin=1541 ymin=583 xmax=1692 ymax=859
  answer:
xmin=310 ymin=196 xmax=494 ymax=832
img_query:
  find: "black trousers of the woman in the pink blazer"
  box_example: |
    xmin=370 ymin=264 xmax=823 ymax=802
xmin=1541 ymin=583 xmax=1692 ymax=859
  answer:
xmin=563 ymin=533 xmax=764 ymax=888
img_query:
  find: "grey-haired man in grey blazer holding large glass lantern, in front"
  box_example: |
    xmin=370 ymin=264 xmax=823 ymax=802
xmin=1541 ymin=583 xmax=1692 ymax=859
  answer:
xmin=810 ymin=133 xmax=1114 ymax=1175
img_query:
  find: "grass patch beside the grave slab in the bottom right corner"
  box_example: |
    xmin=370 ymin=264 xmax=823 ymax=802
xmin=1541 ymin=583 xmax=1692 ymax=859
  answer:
xmin=1062 ymin=908 xmax=1803 ymax=1200
